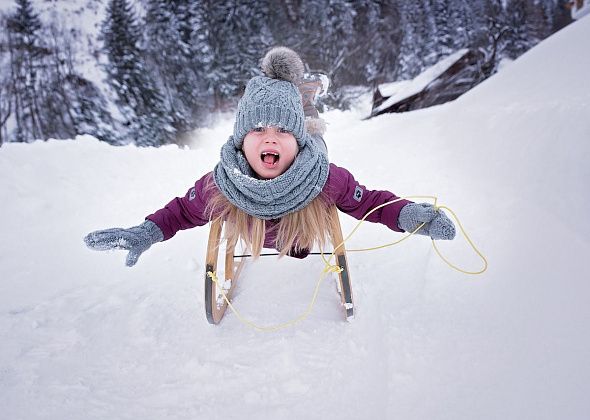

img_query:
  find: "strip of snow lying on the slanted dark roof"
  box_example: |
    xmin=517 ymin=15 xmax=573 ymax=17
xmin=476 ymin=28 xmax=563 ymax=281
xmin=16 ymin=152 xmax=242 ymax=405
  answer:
xmin=374 ymin=48 xmax=469 ymax=112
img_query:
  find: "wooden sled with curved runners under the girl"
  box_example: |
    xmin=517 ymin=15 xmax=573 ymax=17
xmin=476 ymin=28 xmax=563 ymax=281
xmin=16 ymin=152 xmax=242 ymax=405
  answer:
xmin=205 ymin=206 xmax=354 ymax=324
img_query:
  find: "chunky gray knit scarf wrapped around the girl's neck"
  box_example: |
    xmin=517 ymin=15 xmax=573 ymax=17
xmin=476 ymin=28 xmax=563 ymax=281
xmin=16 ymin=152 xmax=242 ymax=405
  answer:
xmin=213 ymin=134 xmax=329 ymax=220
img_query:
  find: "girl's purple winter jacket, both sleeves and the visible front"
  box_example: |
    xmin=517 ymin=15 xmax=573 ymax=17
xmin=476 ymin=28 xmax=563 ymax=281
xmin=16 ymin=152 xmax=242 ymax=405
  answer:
xmin=146 ymin=163 xmax=411 ymax=257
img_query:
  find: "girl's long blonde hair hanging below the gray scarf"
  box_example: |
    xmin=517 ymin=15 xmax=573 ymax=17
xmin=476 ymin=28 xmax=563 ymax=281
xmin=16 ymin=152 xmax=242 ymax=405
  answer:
xmin=205 ymin=177 xmax=333 ymax=258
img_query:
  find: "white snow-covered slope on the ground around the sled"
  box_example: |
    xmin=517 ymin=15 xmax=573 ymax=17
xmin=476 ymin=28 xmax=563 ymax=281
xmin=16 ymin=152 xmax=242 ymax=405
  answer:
xmin=0 ymin=19 xmax=590 ymax=420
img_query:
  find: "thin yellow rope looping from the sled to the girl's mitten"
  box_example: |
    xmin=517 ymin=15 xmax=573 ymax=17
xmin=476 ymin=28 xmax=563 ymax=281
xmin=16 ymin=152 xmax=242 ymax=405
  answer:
xmin=207 ymin=195 xmax=488 ymax=332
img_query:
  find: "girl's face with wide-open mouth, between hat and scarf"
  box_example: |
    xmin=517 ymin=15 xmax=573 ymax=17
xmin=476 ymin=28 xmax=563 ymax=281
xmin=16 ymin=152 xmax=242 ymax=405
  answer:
xmin=242 ymin=127 xmax=299 ymax=179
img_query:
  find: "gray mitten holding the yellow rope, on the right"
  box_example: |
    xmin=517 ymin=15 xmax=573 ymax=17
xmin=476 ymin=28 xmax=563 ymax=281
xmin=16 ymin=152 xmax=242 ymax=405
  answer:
xmin=397 ymin=203 xmax=455 ymax=239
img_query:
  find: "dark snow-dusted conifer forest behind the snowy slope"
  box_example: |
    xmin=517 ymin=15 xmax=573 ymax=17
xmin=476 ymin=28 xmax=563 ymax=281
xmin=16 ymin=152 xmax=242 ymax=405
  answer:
xmin=0 ymin=0 xmax=571 ymax=146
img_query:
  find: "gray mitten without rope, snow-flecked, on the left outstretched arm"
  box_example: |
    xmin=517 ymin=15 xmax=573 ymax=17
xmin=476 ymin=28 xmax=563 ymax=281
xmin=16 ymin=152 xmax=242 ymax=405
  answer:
xmin=84 ymin=220 xmax=164 ymax=267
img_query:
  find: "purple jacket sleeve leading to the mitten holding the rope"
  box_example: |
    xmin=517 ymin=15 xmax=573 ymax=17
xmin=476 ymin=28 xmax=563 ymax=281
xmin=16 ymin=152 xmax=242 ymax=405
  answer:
xmin=324 ymin=163 xmax=411 ymax=232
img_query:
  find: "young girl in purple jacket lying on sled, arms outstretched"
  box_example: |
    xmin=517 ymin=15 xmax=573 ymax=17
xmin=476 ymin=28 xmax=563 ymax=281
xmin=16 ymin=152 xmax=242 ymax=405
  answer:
xmin=84 ymin=47 xmax=455 ymax=266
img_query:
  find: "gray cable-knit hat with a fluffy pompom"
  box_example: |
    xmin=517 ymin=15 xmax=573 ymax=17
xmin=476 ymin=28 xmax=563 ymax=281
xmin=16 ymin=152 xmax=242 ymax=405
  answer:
xmin=233 ymin=47 xmax=308 ymax=149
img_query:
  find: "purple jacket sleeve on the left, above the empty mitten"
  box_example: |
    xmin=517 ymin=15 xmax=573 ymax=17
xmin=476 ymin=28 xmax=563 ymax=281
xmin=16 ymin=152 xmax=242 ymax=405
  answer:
xmin=146 ymin=172 xmax=212 ymax=241
